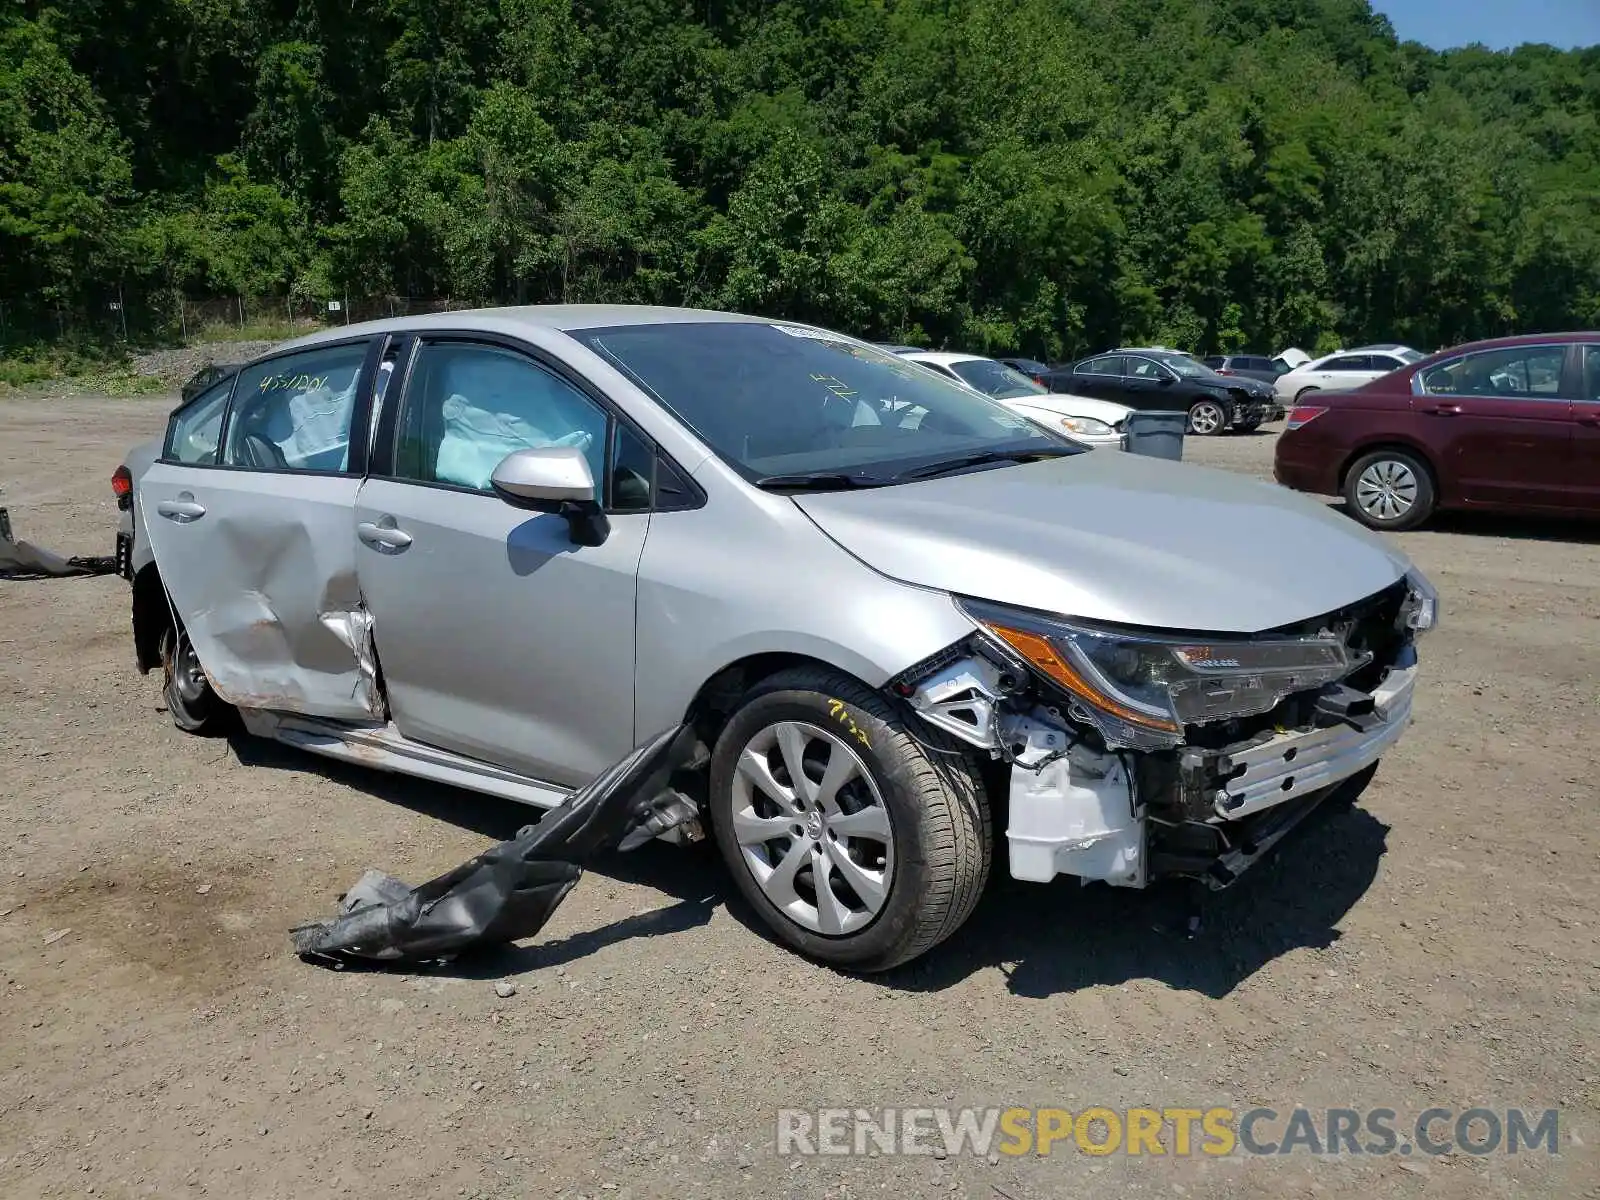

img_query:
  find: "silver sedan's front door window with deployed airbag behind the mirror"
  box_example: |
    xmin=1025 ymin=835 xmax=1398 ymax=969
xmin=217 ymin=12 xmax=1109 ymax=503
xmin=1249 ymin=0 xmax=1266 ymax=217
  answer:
xmin=395 ymin=342 xmax=608 ymax=491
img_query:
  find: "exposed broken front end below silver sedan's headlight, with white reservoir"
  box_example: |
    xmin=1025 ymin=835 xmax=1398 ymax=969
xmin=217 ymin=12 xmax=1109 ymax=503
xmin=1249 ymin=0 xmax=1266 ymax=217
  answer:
xmin=893 ymin=614 xmax=1418 ymax=888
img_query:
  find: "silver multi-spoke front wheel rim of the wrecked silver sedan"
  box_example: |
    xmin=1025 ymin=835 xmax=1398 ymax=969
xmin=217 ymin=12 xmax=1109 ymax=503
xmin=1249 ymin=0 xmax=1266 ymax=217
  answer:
xmin=733 ymin=722 xmax=894 ymax=936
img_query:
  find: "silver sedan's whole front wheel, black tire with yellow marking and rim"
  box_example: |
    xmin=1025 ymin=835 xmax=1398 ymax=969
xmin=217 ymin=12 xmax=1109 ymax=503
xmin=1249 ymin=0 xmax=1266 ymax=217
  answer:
xmin=710 ymin=667 xmax=992 ymax=971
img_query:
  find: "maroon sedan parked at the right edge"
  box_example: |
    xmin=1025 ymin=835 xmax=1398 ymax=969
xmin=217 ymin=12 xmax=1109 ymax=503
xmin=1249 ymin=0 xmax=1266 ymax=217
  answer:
xmin=1274 ymin=333 xmax=1600 ymax=530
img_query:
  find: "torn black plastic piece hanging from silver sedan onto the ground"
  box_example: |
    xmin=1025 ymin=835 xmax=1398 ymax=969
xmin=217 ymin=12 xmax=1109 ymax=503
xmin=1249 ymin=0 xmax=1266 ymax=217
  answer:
xmin=291 ymin=726 xmax=699 ymax=965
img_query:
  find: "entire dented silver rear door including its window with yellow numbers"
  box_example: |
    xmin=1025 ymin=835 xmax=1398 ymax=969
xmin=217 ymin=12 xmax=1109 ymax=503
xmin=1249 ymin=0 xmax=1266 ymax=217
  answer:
xmin=138 ymin=341 xmax=382 ymax=720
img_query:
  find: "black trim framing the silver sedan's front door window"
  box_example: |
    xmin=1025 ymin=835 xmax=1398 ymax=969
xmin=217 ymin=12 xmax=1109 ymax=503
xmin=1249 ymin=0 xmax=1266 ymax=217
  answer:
xmin=366 ymin=328 xmax=707 ymax=517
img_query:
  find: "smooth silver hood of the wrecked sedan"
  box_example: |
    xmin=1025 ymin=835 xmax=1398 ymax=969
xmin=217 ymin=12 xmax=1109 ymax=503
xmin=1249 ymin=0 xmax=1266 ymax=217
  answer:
xmin=795 ymin=453 xmax=1410 ymax=634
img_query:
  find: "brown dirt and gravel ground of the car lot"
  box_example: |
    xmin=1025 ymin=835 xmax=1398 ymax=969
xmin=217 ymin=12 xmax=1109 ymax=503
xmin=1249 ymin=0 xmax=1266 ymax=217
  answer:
xmin=0 ymin=397 xmax=1600 ymax=1200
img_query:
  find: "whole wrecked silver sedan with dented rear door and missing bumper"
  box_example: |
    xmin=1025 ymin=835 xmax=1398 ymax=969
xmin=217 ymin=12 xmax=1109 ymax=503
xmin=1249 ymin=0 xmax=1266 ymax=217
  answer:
xmin=122 ymin=307 xmax=1437 ymax=970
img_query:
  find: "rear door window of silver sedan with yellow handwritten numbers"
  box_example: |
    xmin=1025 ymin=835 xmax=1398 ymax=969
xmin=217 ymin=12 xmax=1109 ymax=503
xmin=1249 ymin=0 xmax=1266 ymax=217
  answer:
xmin=222 ymin=342 xmax=366 ymax=472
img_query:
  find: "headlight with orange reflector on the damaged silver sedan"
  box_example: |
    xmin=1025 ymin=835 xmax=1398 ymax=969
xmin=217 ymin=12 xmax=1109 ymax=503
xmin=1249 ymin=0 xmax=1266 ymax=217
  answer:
xmin=960 ymin=598 xmax=1352 ymax=749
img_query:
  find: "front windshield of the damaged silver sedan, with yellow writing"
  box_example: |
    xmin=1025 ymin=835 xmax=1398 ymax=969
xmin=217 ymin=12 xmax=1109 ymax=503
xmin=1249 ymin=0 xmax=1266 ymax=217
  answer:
xmin=573 ymin=322 xmax=1077 ymax=482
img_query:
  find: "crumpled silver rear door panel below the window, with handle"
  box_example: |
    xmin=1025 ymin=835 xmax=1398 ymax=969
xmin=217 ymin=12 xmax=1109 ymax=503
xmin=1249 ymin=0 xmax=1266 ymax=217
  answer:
xmin=138 ymin=462 xmax=384 ymax=722
